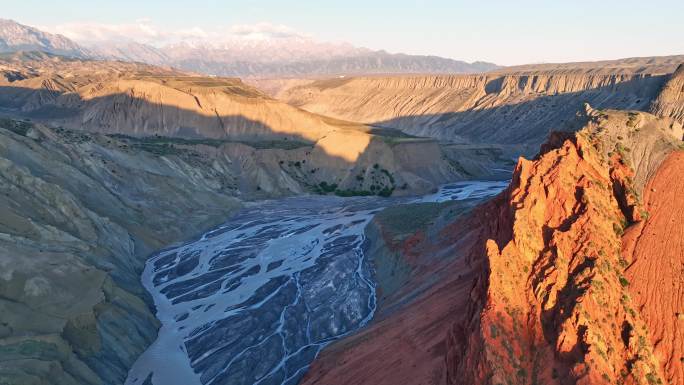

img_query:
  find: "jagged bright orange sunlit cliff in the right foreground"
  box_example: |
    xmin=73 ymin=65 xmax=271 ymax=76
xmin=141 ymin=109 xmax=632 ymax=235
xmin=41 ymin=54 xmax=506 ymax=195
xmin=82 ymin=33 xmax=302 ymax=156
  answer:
xmin=446 ymin=130 xmax=664 ymax=384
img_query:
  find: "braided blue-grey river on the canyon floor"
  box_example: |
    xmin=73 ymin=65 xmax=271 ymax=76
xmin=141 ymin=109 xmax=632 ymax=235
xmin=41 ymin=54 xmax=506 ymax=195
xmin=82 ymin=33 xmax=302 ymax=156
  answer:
xmin=126 ymin=181 xmax=507 ymax=385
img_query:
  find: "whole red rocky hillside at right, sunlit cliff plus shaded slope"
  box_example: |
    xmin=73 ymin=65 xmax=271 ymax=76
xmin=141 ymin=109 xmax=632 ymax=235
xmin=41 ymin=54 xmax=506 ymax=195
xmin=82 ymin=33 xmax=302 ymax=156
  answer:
xmin=305 ymin=108 xmax=682 ymax=384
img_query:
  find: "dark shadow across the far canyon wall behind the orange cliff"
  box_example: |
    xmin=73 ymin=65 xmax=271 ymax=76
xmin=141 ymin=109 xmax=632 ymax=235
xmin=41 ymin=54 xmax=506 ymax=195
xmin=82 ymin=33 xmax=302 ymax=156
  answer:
xmin=371 ymin=75 xmax=670 ymax=150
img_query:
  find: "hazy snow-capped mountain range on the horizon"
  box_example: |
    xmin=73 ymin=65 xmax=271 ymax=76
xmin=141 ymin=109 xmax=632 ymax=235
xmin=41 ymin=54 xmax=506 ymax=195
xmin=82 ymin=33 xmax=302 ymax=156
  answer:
xmin=0 ymin=19 xmax=497 ymax=77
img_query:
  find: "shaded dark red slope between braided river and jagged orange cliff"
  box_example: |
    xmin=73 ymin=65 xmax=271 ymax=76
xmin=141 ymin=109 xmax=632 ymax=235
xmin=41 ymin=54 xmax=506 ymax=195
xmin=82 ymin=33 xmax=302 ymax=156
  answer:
xmin=302 ymin=200 xmax=495 ymax=385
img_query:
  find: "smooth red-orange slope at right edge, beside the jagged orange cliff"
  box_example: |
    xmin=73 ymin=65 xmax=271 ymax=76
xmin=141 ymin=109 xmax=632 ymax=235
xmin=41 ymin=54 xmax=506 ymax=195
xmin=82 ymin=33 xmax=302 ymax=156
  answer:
xmin=622 ymin=151 xmax=684 ymax=384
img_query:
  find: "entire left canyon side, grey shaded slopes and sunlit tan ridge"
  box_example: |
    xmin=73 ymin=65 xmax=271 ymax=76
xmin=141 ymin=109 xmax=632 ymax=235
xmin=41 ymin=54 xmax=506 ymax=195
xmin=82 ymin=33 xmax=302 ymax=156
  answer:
xmin=0 ymin=53 xmax=492 ymax=384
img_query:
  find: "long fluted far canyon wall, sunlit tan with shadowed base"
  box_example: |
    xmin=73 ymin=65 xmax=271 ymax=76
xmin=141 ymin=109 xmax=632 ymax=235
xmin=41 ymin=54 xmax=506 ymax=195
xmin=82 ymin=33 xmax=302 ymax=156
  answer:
xmin=276 ymin=64 xmax=682 ymax=151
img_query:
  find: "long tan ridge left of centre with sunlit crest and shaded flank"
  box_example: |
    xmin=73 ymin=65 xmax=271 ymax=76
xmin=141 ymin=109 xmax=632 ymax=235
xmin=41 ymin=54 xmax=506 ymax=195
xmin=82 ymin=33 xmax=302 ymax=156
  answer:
xmin=0 ymin=55 xmax=470 ymax=195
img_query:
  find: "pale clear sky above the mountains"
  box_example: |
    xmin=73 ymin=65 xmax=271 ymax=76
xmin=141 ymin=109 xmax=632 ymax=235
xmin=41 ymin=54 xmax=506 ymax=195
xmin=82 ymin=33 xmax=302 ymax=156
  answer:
xmin=5 ymin=0 xmax=684 ymax=65
